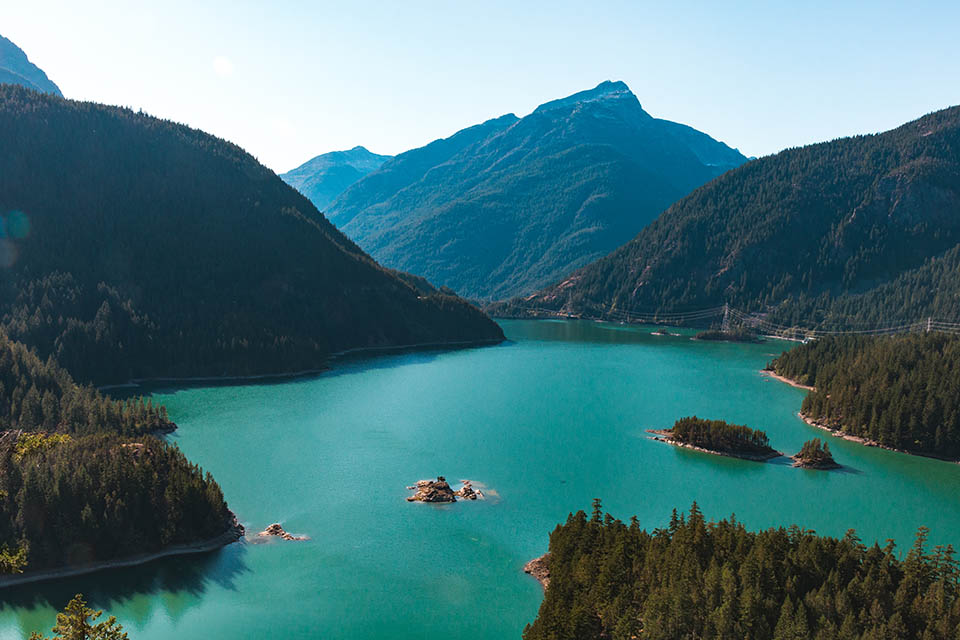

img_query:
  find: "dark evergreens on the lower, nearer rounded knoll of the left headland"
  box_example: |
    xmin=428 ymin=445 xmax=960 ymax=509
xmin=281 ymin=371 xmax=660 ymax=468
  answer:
xmin=0 ymin=434 xmax=229 ymax=571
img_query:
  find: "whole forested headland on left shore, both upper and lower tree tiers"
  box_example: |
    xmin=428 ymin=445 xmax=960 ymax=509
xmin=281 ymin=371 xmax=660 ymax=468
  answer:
xmin=0 ymin=332 xmax=243 ymax=587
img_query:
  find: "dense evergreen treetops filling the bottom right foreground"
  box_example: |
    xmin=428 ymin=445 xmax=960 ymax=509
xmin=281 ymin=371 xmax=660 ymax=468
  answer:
xmin=523 ymin=503 xmax=960 ymax=640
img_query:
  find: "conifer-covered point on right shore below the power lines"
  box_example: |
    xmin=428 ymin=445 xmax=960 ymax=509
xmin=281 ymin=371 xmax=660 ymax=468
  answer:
xmin=770 ymin=332 xmax=960 ymax=459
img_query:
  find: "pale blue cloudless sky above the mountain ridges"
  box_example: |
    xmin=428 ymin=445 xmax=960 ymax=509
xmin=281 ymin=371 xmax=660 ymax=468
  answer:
xmin=0 ymin=0 xmax=960 ymax=171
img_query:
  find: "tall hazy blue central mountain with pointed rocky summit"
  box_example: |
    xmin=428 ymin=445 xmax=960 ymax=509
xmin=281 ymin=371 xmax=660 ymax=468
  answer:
xmin=327 ymin=82 xmax=745 ymax=299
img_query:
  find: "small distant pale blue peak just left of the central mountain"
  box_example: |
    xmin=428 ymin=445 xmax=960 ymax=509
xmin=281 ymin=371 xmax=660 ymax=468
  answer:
xmin=280 ymin=147 xmax=392 ymax=211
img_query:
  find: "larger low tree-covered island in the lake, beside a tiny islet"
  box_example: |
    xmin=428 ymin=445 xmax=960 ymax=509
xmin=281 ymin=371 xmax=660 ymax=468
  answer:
xmin=649 ymin=416 xmax=783 ymax=461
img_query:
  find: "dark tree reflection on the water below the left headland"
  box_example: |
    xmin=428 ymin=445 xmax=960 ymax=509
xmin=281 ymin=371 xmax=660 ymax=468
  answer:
xmin=0 ymin=542 xmax=250 ymax=637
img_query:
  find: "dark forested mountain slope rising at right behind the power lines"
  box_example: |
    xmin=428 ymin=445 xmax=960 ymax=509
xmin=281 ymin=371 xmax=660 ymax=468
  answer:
xmin=512 ymin=107 xmax=960 ymax=326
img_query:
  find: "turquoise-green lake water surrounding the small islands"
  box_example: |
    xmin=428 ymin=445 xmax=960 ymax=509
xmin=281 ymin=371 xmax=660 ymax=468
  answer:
xmin=0 ymin=321 xmax=960 ymax=640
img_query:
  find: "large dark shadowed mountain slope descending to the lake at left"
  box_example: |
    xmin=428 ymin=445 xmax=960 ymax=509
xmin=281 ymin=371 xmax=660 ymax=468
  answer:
xmin=0 ymin=85 xmax=502 ymax=382
